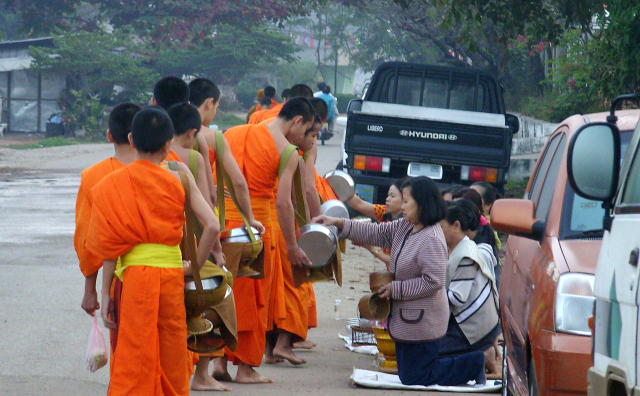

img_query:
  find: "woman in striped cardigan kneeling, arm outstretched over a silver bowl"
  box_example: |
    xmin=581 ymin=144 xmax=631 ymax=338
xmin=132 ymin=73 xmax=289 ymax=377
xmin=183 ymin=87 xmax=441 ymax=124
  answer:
xmin=314 ymin=177 xmax=486 ymax=386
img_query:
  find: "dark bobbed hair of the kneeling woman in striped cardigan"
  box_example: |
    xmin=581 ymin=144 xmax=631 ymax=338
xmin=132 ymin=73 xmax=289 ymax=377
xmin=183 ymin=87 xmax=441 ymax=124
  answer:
xmin=400 ymin=176 xmax=447 ymax=227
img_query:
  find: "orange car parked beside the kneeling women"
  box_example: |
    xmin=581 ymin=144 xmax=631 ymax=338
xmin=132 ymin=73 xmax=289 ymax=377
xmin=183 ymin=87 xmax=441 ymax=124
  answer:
xmin=491 ymin=110 xmax=640 ymax=396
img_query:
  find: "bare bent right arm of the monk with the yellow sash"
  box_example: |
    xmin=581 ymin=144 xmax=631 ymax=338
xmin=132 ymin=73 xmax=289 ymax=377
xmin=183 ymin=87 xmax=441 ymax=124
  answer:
xmin=187 ymin=174 xmax=222 ymax=268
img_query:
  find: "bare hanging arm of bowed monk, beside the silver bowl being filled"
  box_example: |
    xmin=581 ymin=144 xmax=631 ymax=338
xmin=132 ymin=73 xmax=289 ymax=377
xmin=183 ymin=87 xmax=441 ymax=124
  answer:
xmin=276 ymin=154 xmax=311 ymax=266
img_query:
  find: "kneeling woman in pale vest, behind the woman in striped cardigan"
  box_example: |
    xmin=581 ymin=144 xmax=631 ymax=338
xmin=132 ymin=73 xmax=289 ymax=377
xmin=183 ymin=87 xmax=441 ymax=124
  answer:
xmin=440 ymin=199 xmax=501 ymax=374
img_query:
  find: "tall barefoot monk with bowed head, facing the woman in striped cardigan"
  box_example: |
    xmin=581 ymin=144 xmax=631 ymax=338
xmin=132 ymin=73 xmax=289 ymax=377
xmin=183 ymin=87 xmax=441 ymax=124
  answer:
xmin=214 ymin=98 xmax=314 ymax=383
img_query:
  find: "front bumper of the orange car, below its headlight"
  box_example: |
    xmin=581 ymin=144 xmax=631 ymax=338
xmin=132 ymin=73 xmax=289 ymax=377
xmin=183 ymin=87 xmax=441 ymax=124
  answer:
xmin=532 ymin=330 xmax=592 ymax=396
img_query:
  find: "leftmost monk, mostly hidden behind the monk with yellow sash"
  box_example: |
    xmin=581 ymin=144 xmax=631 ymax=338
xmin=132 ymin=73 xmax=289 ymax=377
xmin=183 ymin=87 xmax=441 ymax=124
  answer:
xmin=73 ymin=103 xmax=141 ymax=362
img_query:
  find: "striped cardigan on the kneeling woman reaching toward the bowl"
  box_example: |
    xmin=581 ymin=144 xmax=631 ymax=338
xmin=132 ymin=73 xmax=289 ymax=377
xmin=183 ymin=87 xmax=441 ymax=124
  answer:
xmin=340 ymin=219 xmax=449 ymax=342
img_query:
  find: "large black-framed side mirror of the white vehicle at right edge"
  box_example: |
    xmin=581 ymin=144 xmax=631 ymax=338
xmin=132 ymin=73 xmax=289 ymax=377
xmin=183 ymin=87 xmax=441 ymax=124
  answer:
xmin=567 ymin=122 xmax=620 ymax=203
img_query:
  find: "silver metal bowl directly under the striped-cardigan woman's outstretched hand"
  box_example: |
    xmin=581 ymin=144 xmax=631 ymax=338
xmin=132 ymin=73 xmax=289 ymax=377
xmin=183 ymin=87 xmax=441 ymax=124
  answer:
xmin=296 ymin=224 xmax=338 ymax=268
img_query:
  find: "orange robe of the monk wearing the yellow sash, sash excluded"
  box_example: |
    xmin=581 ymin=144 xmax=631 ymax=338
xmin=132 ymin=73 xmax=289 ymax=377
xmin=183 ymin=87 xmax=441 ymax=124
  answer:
xmin=86 ymin=160 xmax=190 ymax=396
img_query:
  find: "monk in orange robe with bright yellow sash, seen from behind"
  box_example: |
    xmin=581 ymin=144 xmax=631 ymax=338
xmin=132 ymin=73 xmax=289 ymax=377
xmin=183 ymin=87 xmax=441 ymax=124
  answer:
xmin=86 ymin=107 xmax=220 ymax=395
